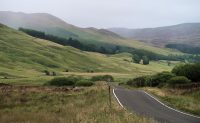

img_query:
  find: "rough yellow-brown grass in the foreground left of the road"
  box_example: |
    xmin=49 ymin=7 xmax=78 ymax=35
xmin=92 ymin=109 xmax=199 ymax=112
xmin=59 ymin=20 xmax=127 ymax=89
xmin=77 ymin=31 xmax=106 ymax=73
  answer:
xmin=0 ymin=82 xmax=154 ymax=123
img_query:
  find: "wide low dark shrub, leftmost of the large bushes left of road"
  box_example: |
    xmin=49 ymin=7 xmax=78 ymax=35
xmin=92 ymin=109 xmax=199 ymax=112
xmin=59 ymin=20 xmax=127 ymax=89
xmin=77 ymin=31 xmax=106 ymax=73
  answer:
xmin=47 ymin=76 xmax=78 ymax=86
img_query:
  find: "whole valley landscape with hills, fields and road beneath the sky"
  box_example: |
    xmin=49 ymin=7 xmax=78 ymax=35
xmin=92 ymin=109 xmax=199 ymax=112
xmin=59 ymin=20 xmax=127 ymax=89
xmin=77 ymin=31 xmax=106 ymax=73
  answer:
xmin=0 ymin=11 xmax=200 ymax=123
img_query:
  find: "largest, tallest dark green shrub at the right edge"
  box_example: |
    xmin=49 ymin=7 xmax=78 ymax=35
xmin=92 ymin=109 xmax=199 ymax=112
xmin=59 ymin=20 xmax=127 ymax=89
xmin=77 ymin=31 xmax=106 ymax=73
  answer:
xmin=172 ymin=63 xmax=200 ymax=82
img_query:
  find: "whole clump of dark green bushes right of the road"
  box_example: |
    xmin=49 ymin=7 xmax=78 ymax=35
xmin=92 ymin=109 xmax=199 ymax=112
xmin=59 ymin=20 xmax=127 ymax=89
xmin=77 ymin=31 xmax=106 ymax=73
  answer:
xmin=127 ymin=63 xmax=200 ymax=87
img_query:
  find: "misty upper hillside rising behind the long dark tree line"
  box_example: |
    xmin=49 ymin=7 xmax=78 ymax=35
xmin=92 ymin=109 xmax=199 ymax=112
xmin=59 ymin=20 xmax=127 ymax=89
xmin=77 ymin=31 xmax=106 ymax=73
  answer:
xmin=0 ymin=11 xmax=180 ymax=55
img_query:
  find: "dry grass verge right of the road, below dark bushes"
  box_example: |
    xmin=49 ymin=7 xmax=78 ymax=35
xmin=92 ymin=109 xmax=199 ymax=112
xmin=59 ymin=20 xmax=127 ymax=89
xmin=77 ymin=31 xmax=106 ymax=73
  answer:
xmin=145 ymin=88 xmax=200 ymax=116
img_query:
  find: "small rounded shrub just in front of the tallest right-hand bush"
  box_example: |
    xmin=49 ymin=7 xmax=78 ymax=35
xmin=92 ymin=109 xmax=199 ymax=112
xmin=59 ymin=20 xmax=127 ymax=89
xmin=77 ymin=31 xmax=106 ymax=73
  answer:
xmin=167 ymin=76 xmax=191 ymax=85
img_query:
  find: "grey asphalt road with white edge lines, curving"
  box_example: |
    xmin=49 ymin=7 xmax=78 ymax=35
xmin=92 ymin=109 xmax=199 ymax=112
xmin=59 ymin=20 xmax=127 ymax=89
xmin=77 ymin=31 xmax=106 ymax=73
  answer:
xmin=113 ymin=87 xmax=200 ymax=123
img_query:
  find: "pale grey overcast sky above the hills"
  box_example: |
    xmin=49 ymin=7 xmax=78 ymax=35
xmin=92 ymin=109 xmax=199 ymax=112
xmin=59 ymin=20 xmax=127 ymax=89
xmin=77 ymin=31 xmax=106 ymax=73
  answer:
xmin=0 ymin=0 xmax=200 ymax=28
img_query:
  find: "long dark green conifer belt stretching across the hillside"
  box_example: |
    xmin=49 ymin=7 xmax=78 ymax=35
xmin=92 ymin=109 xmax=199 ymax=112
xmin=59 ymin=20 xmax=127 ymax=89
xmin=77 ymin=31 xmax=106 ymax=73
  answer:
xmin=19 ymin=28 xmax=200 ymax=64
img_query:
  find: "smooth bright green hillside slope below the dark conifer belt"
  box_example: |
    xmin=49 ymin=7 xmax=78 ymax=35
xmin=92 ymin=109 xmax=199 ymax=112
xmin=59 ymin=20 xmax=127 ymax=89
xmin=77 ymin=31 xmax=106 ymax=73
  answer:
xmin=0 ymin=25 xmax=171 ymax=83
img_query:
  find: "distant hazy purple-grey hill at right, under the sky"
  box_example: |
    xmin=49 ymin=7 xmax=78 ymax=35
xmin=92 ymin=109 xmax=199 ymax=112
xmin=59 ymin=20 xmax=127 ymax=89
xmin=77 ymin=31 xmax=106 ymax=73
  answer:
xmin=108 ymin=23 xmax=200 ymax=46
